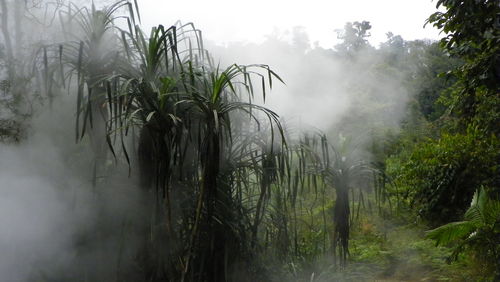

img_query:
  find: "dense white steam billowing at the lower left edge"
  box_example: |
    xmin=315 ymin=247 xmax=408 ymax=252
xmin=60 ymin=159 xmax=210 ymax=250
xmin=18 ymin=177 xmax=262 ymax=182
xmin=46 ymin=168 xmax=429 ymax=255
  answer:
xmin=0 ymin=94 xmax=91 ymax=281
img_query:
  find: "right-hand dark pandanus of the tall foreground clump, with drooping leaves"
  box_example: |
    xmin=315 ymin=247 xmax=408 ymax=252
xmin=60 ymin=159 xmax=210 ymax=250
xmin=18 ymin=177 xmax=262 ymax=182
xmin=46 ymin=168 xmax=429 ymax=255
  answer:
xmin=175 ymin=62 xmax=283 ymax=281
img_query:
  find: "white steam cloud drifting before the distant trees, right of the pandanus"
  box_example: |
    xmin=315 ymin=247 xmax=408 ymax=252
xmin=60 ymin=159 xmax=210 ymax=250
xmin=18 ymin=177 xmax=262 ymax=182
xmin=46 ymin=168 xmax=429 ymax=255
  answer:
xmin=207 ymin=28 xmax=410 ymax=137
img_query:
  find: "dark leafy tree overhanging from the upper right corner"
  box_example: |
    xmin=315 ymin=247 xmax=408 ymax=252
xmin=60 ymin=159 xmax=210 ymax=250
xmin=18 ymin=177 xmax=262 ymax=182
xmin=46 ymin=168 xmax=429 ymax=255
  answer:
xmin=428 ymin=0 xmax=500 ymax=136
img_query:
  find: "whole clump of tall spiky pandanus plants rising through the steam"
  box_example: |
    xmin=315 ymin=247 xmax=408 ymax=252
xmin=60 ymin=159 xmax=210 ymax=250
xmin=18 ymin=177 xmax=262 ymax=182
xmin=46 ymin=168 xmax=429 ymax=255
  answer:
xmin=47 ymin=1 xmax=290 ymax=281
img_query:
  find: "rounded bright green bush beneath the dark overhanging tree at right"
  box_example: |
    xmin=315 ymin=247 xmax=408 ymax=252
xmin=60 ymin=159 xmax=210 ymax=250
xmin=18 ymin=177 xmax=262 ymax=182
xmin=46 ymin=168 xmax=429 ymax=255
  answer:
xmin=393 ymin=127 xmax=500 ymax=224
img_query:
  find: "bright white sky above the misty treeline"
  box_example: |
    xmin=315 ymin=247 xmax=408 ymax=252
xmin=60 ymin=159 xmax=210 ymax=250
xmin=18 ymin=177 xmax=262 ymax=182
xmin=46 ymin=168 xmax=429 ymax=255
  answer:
xmin=138 ymin=0 xmax=439 ymax=47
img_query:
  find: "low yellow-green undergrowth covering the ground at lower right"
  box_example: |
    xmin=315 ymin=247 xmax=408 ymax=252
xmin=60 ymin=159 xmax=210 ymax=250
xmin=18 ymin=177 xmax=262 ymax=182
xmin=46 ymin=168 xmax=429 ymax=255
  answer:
xmin=274 ymin=213 xmax=492 ymax=282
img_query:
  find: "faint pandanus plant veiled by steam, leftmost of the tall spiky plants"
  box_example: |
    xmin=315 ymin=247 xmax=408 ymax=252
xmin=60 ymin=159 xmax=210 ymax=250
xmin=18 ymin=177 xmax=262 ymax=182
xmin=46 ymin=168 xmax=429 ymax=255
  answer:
xmin=53 ymin=1 xmax=131 ymax=186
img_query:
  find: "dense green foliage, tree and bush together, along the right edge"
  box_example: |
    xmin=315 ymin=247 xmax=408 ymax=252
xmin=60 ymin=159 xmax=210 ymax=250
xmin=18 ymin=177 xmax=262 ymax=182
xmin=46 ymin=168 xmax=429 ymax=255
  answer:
xmin=386 ymin=1 xmax=500 ymax=279
